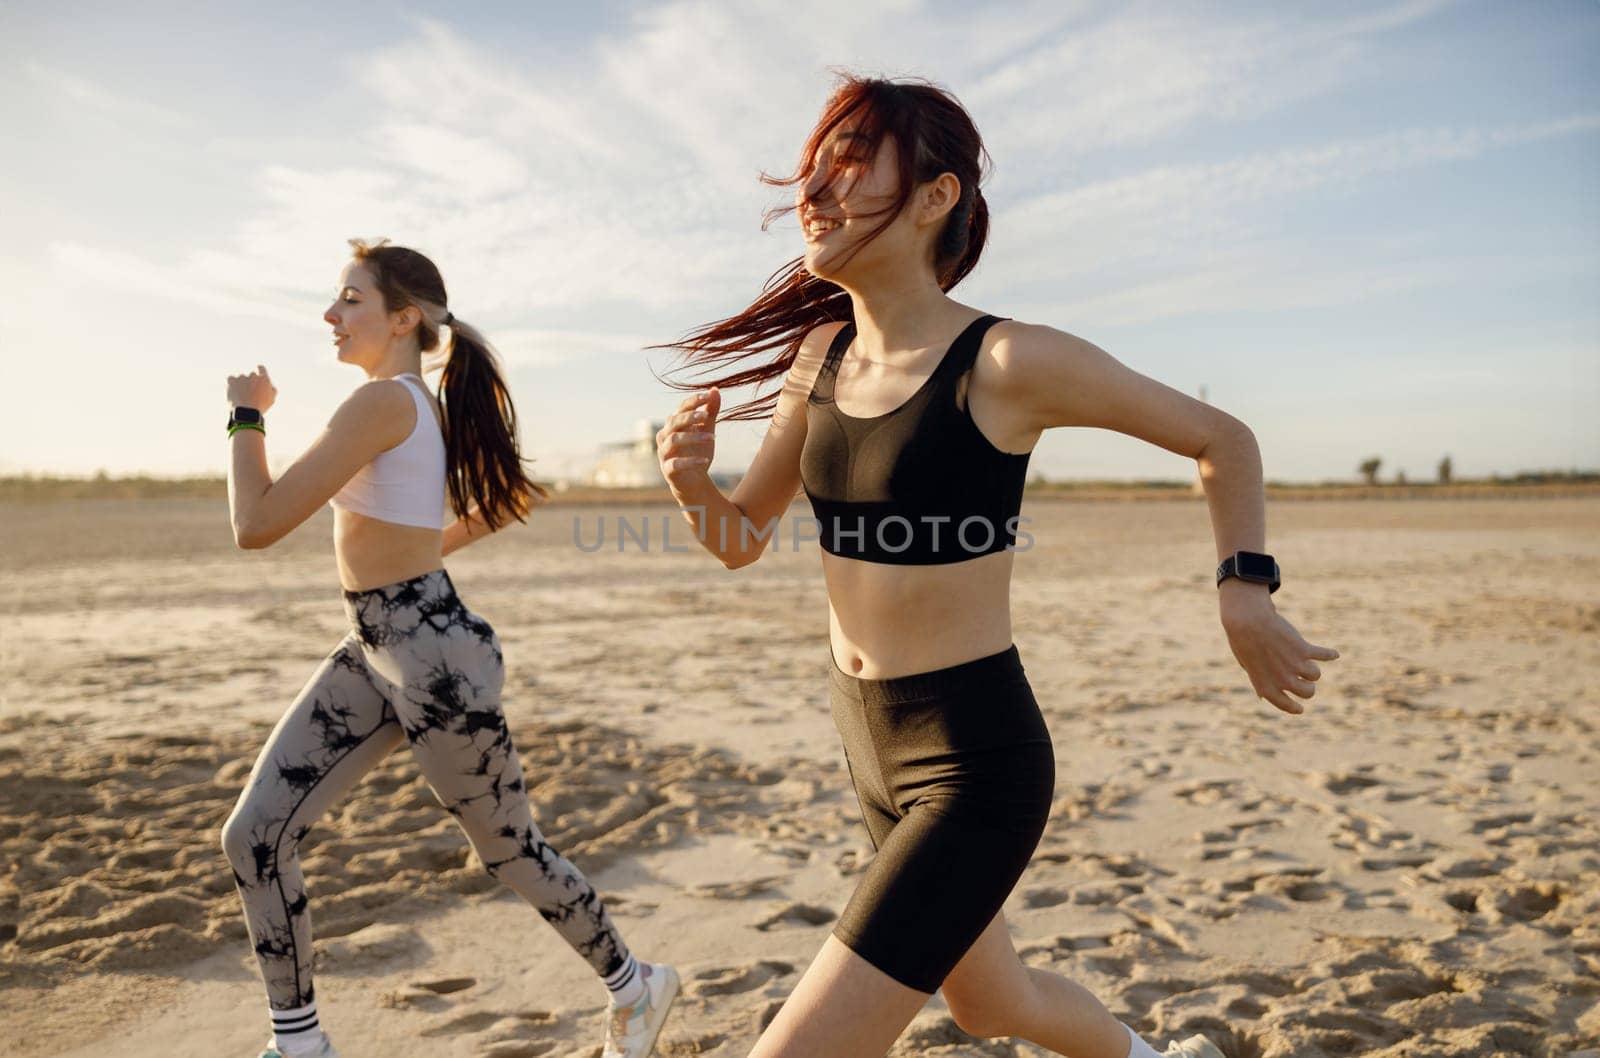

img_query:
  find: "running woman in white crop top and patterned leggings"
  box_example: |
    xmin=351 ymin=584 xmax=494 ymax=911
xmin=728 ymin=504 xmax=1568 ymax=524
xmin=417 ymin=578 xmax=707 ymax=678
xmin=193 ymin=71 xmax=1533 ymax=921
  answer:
xmin=221 ymin=240 xmax=677 ymax=1058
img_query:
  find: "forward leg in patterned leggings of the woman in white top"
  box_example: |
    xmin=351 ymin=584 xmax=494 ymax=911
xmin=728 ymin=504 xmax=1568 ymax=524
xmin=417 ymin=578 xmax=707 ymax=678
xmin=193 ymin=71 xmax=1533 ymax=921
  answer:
xmin=222 ymin=635 xmax=405 ymax=1010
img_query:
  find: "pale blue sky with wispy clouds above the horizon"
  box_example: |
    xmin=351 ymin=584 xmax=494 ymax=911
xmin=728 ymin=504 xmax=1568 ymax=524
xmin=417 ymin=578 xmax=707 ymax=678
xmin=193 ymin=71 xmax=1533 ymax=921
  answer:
xmin=0 ymin=0 xmax=1600 ymax=482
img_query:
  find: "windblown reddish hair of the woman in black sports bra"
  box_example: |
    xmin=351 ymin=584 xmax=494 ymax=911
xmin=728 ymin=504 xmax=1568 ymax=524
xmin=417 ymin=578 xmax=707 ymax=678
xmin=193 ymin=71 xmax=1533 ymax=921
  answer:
xmin=651 ymin=74 xmax=989 ymax=419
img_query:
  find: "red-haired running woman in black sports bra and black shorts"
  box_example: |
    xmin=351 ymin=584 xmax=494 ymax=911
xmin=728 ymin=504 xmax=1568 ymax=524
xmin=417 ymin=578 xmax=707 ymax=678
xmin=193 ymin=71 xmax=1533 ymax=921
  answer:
xmin=658 ymin=78 xmax=1338 ymax=1058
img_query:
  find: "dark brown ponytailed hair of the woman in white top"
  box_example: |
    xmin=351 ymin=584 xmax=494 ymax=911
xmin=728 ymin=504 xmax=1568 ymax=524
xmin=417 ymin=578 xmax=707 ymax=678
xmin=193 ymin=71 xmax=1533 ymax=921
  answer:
xmin=350 ymin=238 xmax=549 ymax=528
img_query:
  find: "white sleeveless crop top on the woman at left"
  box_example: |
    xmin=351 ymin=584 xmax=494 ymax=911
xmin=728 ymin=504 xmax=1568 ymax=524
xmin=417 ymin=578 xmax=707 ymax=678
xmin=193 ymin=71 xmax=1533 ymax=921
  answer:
xmin=328 ymin=373 xmax=451 ymax=528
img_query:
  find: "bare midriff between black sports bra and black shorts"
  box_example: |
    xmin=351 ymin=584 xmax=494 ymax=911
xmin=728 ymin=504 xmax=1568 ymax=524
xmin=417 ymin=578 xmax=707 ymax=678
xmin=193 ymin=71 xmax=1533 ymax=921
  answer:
xmin=822 ymin=551 xmax=1013 ymax=680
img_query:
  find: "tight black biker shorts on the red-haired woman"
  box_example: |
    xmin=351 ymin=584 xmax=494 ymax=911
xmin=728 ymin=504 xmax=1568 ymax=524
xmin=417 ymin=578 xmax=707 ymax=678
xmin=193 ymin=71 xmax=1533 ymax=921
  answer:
xmin=829 ymin=643 xmax=1056 ymax=992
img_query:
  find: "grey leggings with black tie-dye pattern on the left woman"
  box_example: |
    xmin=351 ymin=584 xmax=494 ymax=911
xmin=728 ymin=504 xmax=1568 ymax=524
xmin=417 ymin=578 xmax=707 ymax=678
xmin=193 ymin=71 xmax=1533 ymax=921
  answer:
xmin=222 ymin=570 xmax=627 ymax=1010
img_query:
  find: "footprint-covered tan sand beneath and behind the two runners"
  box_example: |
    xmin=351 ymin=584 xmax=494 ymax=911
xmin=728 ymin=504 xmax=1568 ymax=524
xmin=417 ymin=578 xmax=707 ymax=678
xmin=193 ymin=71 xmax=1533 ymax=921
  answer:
xmin=0 ymin=498 xmax=1600 ymax=1058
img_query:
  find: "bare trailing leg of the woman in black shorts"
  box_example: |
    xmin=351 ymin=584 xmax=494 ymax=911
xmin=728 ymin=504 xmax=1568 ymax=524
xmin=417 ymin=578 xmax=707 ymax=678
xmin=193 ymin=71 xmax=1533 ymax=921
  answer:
xmin=939 ymin=914 xmax=1133 ymax=1058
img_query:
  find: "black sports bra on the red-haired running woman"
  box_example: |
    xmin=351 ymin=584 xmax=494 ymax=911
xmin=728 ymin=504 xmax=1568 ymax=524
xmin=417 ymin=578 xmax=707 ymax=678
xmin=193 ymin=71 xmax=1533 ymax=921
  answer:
xmin=800 ymin=315 xmax=1032 ymax=565
